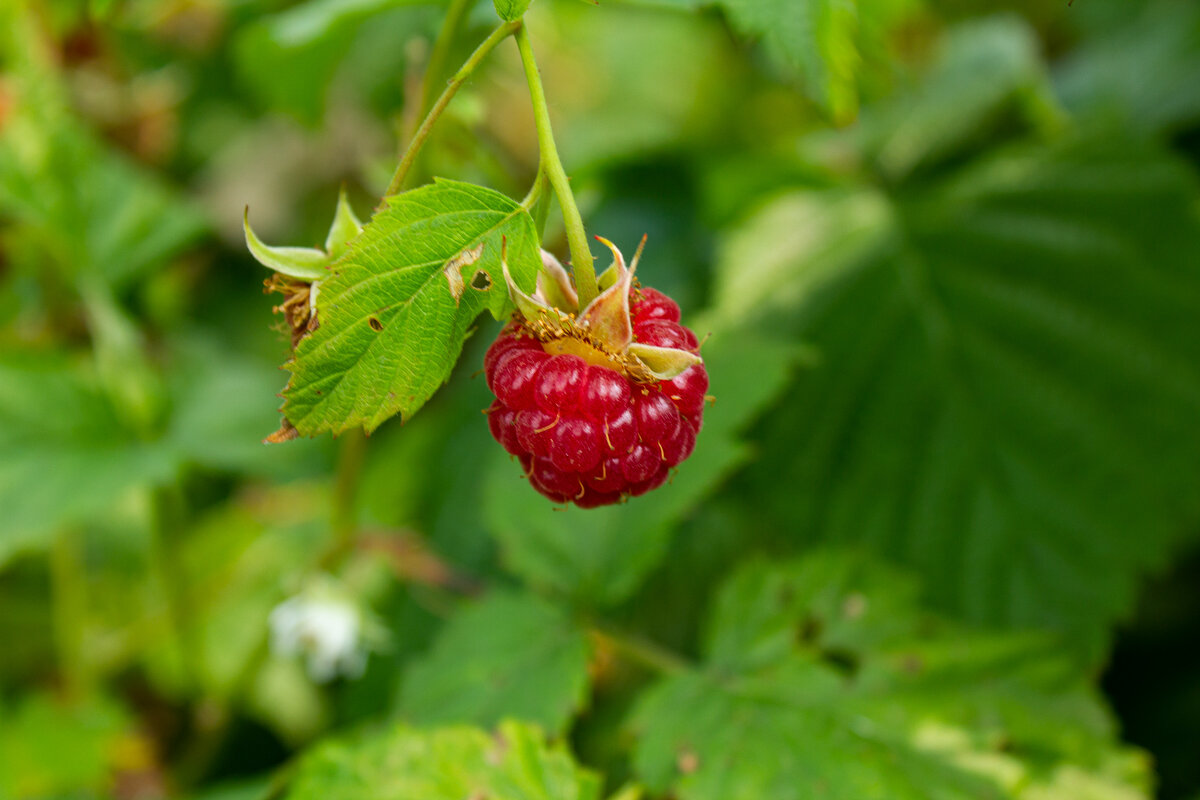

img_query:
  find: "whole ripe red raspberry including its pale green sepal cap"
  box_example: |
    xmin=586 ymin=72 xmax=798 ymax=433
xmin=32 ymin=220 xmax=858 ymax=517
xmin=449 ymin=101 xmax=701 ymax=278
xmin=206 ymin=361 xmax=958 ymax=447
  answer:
xmin=484 ymin=240 xmax=708 ymax=509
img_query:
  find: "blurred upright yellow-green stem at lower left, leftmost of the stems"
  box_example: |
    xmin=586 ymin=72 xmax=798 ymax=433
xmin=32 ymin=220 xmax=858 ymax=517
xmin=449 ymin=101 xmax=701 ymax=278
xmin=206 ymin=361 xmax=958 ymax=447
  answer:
xmin=50 ymin=529 xmax=91 ymax=699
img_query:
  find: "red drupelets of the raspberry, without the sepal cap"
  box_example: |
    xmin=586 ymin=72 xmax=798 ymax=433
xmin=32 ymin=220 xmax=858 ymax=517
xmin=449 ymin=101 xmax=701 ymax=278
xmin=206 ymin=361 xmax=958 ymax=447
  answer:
xmin=484 ymin=289 xmax=708 ymax=509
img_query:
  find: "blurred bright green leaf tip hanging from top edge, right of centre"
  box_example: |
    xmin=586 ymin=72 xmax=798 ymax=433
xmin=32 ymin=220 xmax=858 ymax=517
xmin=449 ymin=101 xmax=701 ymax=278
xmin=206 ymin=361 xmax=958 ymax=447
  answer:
xmin=720 ymin=0 xmax=859 ymax=122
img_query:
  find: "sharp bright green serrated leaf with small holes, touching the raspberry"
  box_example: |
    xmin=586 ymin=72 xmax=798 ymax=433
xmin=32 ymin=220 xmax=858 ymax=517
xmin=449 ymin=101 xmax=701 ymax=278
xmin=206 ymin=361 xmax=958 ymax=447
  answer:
xmin=282 ymin=180 xmax=541 ymax=435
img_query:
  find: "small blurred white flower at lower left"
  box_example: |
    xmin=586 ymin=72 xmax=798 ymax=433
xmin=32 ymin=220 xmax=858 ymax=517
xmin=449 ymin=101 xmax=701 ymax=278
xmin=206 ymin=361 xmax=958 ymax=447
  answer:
xmin=270 ymin=585 xmax=367 ymax=684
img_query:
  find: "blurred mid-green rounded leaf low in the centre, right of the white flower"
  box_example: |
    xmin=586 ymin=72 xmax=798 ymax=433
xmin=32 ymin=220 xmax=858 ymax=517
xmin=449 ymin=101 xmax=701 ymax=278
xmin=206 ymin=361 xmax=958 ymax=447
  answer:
xmin=400 ymin=594 xmax=589 ymax=733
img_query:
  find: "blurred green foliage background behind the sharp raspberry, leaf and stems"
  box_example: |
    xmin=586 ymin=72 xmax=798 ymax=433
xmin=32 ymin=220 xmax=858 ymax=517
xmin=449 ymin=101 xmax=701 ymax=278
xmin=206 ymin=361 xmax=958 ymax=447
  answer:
xmin=0 ymin=0 xmax=1200 ymax=800
